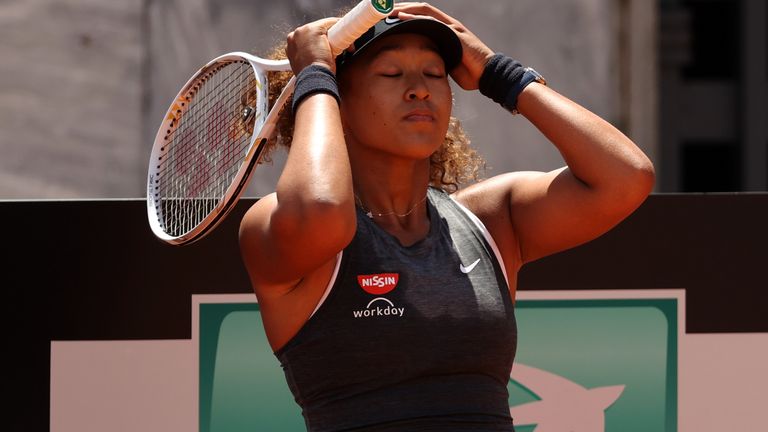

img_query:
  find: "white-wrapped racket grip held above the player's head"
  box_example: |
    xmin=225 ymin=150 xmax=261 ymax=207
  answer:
xmin=328 ymin=0 xmax=395 ymax=57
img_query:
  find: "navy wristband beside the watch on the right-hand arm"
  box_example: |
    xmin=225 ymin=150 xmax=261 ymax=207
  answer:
xmin=479 ymin=53 xmax=535 ymax=113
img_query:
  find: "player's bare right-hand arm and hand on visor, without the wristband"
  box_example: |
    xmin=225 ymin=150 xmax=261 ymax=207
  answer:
xmin=395 ymin=3 xmax=654 ymax=267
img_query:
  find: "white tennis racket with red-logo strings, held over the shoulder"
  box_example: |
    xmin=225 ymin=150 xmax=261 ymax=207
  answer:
xmin=147 ymin=0 xmax=394 ymax=245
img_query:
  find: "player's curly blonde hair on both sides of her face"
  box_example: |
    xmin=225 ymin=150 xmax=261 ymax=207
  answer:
xmin=262 ymin=43 xmax=485 ymax=193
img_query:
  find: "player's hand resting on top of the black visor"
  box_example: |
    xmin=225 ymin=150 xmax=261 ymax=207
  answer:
xmin=392 ymin=2 xmax=494 ymax=90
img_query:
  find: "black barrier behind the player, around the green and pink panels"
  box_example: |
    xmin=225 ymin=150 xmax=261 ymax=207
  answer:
xmin=0 ymin=193 xmax=768 ymax=431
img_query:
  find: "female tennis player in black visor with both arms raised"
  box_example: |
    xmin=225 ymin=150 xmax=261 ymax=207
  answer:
xmin=240 ymin=3 xmax=654 ymax=431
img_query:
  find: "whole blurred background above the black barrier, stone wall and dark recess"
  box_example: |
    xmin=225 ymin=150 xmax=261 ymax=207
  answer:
xmin=0 ymin=0 xmax=768 ymax=200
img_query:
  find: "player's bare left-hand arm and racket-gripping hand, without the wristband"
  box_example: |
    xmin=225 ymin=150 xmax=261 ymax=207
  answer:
xmin=240 ymin=19 xmax=355 ymax=296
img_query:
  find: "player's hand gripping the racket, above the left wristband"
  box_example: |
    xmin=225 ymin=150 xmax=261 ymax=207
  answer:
xmin=285 ymin=18 xmax=339 ymax=74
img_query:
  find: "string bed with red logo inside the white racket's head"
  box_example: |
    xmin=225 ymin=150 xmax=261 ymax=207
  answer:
xmin=157 ymin=62 xmax=258 ymax=236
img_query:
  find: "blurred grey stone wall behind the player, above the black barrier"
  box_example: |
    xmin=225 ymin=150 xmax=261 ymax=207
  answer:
xmin=0 ymin=0 xmax=653 ymax=199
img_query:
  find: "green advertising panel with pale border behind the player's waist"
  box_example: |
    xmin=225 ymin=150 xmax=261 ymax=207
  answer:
xmin=193 ymin=290 xmax=684 ymax=432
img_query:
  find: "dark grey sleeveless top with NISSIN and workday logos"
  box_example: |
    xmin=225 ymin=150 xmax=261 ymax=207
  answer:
xmin=275 ymin=188 xmax=517 ymax=431
